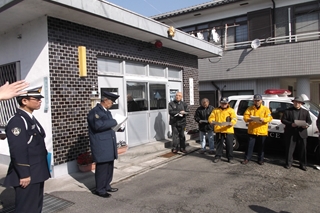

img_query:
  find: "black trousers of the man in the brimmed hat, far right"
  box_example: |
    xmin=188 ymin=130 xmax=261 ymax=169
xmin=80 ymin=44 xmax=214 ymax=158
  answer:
xmin=286 ymin=136 xmax=307 ymax=166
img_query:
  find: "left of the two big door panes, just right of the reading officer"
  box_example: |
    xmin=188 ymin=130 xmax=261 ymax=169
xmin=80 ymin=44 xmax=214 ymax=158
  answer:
xmin=127 ymin=82 xmax=148 ymax=112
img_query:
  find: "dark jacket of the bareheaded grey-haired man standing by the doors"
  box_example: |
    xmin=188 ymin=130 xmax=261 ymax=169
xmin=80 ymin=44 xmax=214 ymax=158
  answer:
xmin=169 ymin=100 xmax=189 ymax=126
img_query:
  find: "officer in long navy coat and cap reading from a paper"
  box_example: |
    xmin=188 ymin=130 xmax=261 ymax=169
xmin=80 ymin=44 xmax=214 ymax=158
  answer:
xmin=87 ymin=92 xmax=119 ymax=198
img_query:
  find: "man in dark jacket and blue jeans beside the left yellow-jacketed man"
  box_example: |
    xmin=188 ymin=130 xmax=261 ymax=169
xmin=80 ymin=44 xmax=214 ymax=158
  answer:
xmin=194 ymin=98 xmax=214 ymax=154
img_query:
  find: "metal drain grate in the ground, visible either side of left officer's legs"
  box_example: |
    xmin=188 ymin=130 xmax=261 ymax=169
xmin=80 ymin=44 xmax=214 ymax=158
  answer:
xmin=0 ymin=194 xmax=74 ymax=213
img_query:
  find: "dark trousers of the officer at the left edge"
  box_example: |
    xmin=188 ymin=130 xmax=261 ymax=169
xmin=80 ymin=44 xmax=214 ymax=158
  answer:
xmin=14 ymin=182 xmax=44 ymax=213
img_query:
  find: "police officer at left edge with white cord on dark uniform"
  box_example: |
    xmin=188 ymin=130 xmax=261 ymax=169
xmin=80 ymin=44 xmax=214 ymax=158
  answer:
xmin=4 ymin=85 xmax=50 ymax=213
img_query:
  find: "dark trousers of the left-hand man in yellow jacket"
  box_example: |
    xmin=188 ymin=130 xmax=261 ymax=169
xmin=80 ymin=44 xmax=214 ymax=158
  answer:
xmin=215 ymin=133 xmax=234 ymax=160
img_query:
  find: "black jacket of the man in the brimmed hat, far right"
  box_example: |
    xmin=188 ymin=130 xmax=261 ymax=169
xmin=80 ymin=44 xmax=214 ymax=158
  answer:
xmin=281 ymin=107 xmax=312 ymax=138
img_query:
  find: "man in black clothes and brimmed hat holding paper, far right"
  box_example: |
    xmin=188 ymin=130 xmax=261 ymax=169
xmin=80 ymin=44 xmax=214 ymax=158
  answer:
xmin=281 ymin=96 xmax=312 ymax=171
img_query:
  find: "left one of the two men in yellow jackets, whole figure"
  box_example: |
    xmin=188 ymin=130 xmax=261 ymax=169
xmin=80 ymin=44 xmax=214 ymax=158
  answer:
xmin=208 ymin=98 xmax=237 ymax=164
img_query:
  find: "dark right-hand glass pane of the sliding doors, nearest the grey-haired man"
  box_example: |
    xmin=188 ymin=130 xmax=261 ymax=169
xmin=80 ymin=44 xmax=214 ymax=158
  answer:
xmin=149 ymin=84 xmax=167 ymax=110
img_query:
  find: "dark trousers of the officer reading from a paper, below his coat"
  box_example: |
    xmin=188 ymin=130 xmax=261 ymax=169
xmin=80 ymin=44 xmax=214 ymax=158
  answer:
xmin=95 ymin=161 xmax=114 ymax=194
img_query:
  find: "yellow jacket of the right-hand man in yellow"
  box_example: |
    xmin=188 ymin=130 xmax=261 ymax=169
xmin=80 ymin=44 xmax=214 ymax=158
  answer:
xmin=243 ymin=105 xmax=273 ymax=136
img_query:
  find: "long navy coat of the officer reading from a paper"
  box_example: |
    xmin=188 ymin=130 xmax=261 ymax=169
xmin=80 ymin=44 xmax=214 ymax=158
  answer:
xmin=87 ymin=104 xmax=118 ymax=163
